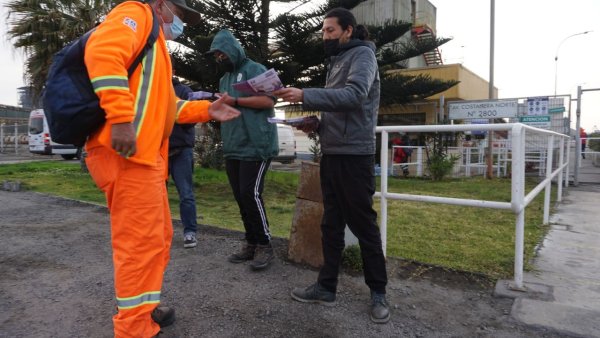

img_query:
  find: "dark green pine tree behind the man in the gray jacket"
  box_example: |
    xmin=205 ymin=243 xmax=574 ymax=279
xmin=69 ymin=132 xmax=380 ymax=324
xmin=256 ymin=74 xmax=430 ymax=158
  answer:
xmin=272 ymin=0 xmax=458 ymax=106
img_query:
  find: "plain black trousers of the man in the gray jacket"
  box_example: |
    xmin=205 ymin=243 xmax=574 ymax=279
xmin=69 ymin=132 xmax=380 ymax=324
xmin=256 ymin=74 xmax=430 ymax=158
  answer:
xmin=318 ymin=155 xmax=387 ymax=293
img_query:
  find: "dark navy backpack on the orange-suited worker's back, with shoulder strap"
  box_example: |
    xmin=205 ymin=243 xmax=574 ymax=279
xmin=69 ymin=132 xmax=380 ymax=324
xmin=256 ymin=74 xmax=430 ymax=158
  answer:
xmin=42 ymin=11 xmax=159 ymax=146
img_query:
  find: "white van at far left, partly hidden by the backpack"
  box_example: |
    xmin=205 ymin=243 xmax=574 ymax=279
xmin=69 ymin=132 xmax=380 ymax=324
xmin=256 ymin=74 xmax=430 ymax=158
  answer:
xmin=29 ymin=109 xmax=81 ymax=160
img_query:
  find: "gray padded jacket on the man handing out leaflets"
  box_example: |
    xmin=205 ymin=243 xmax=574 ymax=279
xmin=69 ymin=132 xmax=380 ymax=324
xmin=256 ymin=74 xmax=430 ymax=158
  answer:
xmin=302 ymin=39 xmax=380 ymax=155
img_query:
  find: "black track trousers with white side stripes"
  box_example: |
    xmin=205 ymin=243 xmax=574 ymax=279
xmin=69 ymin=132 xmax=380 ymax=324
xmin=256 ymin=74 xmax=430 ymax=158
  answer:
xmin=225 ymin=160 xmax=271 ymax=245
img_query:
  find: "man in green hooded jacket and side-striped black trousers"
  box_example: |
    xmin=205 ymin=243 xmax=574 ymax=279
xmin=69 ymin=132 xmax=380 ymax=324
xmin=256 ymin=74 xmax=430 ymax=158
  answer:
xmin=209 ymin=30 xmax=279 ymax=270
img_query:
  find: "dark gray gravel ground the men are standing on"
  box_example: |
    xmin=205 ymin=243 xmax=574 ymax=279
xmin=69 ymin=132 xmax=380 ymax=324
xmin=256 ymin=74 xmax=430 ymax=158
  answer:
xmin=0 ymin=191 xmax=559 ymax=337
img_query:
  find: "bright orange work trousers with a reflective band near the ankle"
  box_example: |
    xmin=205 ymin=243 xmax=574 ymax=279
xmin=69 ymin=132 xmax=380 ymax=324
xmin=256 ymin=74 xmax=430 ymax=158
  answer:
xmin=94 ymin=150 xmax=173 ymax=337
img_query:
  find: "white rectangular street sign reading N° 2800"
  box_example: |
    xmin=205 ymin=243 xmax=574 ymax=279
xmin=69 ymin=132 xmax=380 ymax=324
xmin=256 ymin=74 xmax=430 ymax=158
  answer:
xmin=448 ymin=100 xmax=518 ymax=120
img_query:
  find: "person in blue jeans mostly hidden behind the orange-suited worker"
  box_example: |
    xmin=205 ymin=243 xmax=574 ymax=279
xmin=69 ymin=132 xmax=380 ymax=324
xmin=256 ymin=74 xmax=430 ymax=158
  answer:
xmin=169 ymin=76 xmax=198 ymax=248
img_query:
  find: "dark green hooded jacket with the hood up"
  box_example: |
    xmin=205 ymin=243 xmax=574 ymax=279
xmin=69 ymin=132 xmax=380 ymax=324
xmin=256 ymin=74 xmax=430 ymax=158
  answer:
xmin=210 ymin=29 xmax=279 ymax=161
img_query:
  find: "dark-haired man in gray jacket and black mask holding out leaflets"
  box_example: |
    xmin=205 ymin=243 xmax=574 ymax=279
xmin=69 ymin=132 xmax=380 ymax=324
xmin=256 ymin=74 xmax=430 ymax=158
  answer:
xmin=274 ymin=8 xmax=390 ymax=323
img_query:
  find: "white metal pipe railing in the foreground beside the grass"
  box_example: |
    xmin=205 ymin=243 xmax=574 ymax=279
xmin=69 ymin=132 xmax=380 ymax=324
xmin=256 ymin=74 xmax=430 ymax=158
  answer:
xmin=375 ymin=123 xmax=570 ymax=290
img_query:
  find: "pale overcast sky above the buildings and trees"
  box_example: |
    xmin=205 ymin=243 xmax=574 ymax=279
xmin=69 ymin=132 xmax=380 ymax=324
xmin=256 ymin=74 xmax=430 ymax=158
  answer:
xmin=0 ymin=0 xmax=600 ymax=130
